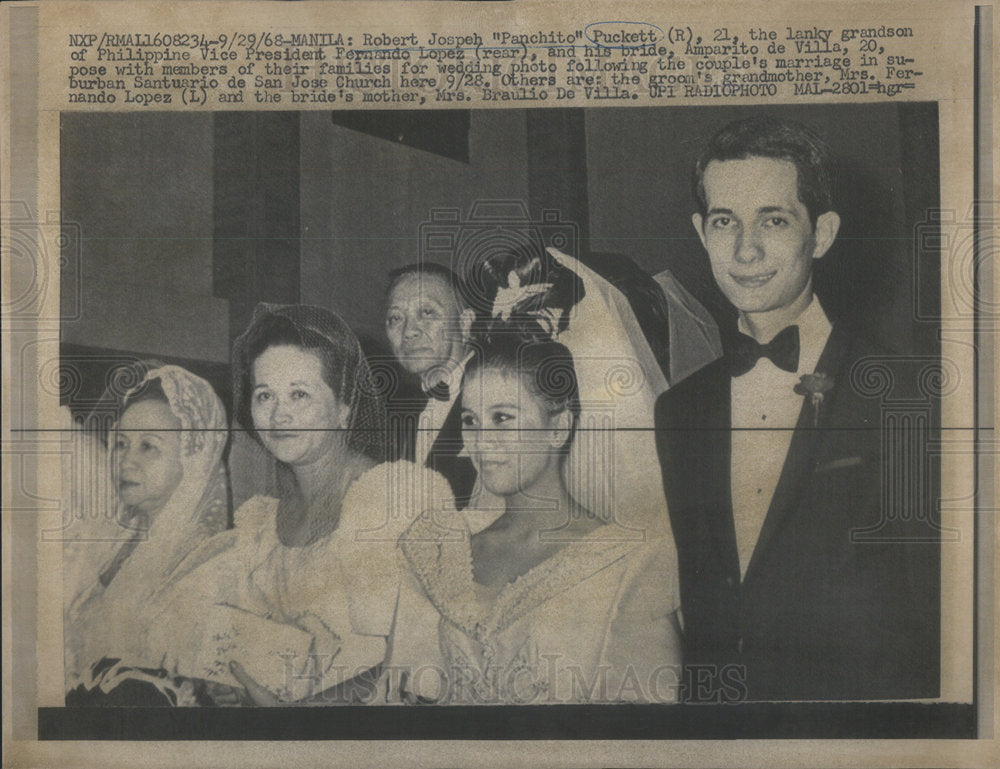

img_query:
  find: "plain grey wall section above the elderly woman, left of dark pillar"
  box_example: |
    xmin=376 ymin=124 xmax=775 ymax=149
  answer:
xmin=61 ymin=114 xmax=228 ymax=362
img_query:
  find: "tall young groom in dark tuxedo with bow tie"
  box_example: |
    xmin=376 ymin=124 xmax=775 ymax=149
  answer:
xmin=655 ymin=118 xmax=940 ymax=701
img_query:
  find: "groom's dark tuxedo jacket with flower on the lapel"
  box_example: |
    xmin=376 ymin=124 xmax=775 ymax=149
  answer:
xmin=656 ymin=326 xmax=940 ymax=701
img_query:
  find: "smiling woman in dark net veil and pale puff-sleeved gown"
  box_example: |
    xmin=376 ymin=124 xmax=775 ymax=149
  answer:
xmin=154 ymin=305 xmax=447 ymax=704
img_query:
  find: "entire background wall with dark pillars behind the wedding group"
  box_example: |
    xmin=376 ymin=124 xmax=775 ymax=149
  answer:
xmin=61 ymin=104 xmax=938 ymax=410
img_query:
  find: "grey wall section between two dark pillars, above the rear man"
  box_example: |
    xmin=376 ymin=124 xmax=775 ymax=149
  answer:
xmin=300 ymin=110 xmax=528 ymax=342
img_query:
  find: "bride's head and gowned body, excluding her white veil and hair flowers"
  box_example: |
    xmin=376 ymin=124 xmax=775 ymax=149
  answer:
xmin=391 ymin=320 xmax=680 ymax=705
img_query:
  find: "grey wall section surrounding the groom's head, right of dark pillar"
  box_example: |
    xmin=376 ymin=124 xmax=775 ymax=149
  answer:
xmin=586 ymin=104 xmax=938 ymax=349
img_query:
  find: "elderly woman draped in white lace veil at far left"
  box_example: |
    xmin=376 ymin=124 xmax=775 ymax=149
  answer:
xmin=63 ymin=363 xmax=229 ymax=704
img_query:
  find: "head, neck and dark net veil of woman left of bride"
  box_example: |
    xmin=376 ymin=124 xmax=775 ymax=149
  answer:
xmin=233 ymin=305 xmax=385 ymax=546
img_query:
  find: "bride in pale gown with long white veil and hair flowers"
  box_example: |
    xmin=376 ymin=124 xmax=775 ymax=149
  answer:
xmin=391 ymin=252 xmax=680 ymax=704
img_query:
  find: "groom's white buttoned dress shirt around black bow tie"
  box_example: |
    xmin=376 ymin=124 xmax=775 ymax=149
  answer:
xmin=732 ymin=297 xmax=831 ymax=575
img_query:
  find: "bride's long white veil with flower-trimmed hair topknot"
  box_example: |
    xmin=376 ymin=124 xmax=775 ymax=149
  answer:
xmin=467 ymin=244 xmax=667 ymax=537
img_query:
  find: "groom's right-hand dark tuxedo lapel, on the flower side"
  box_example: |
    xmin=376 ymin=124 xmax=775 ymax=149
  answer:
xmin=744 ymin=326 xmax=850 ymax=582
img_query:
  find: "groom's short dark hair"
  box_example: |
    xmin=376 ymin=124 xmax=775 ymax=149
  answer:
xmin=692 ymin=117 xmax=833 ymax=226
